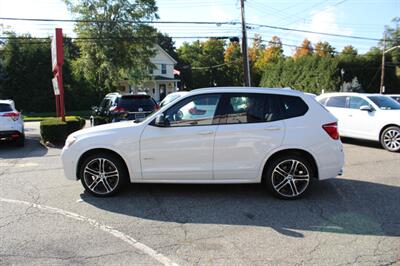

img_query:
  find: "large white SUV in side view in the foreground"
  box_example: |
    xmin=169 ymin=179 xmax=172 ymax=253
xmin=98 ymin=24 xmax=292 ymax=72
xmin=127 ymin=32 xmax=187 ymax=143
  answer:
xmin=61 ymin=88 xmax=344 ymax=199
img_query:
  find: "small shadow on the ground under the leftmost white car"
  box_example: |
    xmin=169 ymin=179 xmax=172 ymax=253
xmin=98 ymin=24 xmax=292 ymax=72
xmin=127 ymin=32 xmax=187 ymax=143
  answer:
xmin=0 ymin=137 xmax=47 ymax=159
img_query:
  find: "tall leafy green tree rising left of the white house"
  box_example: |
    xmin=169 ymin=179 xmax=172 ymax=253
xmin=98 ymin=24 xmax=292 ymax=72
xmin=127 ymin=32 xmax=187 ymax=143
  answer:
xmin=64 ymin=0 xmax=158 ymax=91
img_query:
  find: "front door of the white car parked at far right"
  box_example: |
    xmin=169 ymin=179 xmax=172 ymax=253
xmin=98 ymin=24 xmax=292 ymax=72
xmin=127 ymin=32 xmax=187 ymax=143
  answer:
xmin=346 ymin=96 xmax=379 ymax=139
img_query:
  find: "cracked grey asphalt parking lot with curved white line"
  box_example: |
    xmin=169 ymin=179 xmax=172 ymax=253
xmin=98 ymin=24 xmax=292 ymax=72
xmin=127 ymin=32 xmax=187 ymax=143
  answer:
xmin=0 ymin=123 xmax=400 ymax=265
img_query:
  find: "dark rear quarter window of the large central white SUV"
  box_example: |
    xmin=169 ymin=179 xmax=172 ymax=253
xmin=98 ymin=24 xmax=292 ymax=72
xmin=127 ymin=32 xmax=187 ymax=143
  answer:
xmin=279 ymin=95 xmax=308 ymax=119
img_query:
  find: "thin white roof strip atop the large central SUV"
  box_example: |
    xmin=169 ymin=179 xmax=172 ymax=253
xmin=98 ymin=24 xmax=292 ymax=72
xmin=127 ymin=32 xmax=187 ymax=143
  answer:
xmin=189 ymin=87 xmax=304 ymax=96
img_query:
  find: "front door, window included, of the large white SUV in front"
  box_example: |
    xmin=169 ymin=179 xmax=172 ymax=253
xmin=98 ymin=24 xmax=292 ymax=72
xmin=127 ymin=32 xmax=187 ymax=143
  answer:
xmin=140 ymin=94 xmax=221 ymax=181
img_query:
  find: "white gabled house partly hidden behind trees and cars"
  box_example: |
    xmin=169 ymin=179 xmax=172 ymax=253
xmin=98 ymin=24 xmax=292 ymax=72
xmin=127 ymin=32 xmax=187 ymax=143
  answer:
xmin=121 ymin=45 xmax=179 ymax=101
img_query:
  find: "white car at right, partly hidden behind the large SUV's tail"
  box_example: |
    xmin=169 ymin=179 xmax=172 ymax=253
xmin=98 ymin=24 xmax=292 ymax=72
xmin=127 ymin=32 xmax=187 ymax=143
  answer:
xmin=317 ymin=92 xmax=400 ymax=152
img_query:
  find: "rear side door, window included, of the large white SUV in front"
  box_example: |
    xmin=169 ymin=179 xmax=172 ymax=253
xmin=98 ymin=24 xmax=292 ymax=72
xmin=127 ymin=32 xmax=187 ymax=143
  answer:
xmin=214 ymin=93 xmax=284 ymax=180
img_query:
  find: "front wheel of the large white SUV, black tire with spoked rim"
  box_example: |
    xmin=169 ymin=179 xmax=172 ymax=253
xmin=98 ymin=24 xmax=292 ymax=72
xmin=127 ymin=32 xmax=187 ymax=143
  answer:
xmin=79 ymin=153 xmax=129 ymax=197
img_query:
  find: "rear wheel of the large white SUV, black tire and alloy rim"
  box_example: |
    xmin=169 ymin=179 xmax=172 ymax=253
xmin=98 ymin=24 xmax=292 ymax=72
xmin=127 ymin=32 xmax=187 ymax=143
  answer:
xmin=264 ymin=154 xmax=315 ymax=200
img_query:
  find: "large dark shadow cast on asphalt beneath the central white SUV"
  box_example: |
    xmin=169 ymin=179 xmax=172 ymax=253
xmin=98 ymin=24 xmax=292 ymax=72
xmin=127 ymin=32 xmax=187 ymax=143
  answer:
xmin=81 ymin=179 xmax=400 ymax=237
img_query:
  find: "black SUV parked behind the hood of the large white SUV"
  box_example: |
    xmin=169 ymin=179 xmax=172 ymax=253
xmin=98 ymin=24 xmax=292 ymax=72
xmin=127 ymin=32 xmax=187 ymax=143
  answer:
xmin=90 ymin=93 xmax=158 ymax=126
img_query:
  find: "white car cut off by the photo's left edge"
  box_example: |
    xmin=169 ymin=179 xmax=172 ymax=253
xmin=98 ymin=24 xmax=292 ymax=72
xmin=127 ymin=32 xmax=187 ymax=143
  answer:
xmin=0 ymin=100 xmax=25 ymax=147
